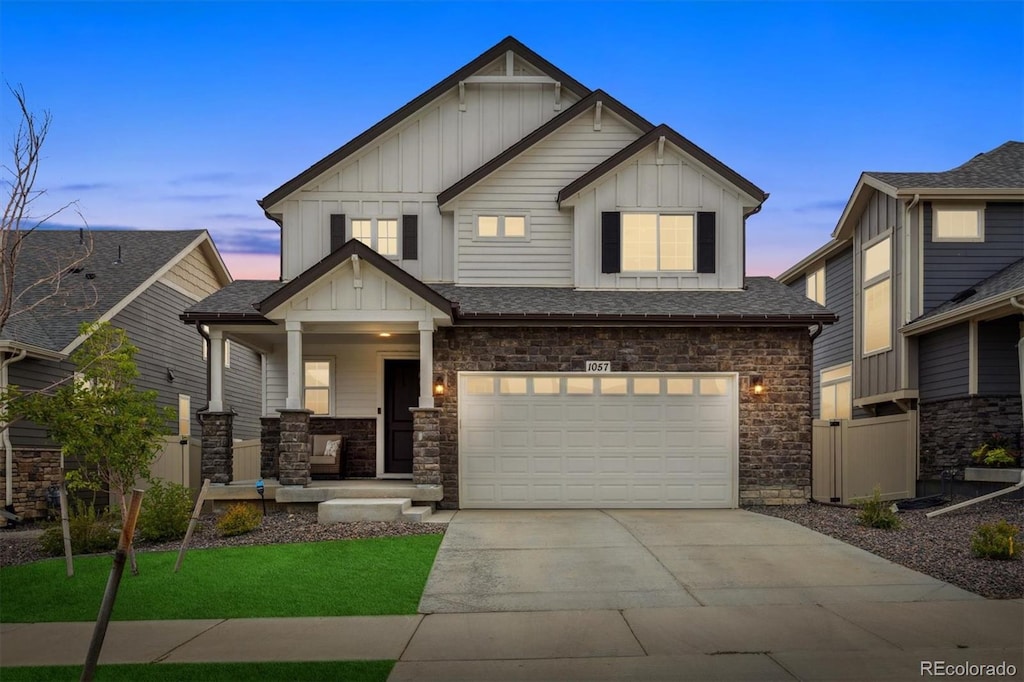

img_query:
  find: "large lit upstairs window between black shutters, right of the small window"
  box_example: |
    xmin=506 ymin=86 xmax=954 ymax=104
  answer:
xmin=623 ymin=213 xmax=693 ymax=272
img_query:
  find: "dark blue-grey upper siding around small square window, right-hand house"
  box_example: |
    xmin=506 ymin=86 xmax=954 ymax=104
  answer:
xmin=923 ymin=202 xmax=1024 ymax=312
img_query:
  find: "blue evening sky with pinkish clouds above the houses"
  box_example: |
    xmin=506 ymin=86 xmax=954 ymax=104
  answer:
xmin=0 ymin=0 xmax=1024 ymax=279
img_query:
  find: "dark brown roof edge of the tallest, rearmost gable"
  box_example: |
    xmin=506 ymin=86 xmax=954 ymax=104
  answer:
xmin=257 ymin=36 xmax=590 ymax=210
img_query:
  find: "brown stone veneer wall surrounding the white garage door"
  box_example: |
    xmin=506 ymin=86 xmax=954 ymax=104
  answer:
xmin=434 ymin=327 xmax=811 ymax=509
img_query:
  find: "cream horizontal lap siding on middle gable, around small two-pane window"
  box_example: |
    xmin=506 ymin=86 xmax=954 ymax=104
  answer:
xmin=454 ymin=108 xmax=640 ymax=287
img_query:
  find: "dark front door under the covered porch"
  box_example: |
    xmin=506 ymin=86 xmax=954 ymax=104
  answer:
xmin=384 ymin=359 xmax=420 ymax=473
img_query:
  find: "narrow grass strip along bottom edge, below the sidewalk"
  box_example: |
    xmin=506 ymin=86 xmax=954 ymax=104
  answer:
xmin=3 ymin=660 xmax=394 ymax=682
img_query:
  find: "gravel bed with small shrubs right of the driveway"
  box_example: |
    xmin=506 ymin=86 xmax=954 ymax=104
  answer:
xmin=755 ymin=499 xmax=1024 ymax=599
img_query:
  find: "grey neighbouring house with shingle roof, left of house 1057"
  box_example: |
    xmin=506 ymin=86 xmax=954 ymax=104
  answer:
xmin=0 ymin=229 xmax=261 ymax=517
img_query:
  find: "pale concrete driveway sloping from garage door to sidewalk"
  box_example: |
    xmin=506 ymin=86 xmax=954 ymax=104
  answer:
xmin=420 ymin=509 xmax=981 ymax=613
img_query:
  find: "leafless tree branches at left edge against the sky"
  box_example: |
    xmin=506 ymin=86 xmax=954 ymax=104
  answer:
xmin=0 ymin=85 xmax=95 ymax=333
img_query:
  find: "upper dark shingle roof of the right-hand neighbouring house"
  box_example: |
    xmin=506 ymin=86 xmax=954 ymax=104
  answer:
xmin=864 ymin=141 xmax=1024 ymax=189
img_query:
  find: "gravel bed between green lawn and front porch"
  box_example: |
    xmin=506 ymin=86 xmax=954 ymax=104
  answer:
xmin=0 ymin=511 xmax=447 ymax=566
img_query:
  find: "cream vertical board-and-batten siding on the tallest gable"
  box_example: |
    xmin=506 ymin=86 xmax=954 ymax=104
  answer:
xmin=268 ymin=57 xmax=579 ymax=282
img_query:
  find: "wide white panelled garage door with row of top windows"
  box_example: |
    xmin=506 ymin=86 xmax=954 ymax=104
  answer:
xmin=459 ymin=372 xmax=739 ymax=508
